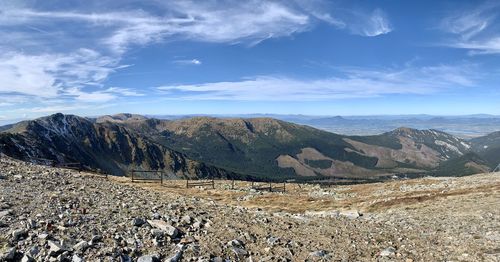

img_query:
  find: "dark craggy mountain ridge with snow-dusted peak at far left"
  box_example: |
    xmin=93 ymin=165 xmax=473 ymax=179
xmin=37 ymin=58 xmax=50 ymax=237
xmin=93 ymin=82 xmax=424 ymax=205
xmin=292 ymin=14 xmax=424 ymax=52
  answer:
xmin=0 ymin=114 xmax=242 ymax=177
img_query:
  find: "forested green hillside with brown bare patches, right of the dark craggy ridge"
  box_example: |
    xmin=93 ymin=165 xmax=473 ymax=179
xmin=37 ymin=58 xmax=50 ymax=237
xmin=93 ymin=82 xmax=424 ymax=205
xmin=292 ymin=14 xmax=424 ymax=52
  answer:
xmin=104 ymin=117 xmax=480 ymax=179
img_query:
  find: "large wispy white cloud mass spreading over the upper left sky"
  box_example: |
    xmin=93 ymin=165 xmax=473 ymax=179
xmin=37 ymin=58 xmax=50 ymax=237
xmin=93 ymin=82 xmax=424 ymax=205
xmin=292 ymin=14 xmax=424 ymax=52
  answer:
xmin=0 ymin=0 xmax=392 ymax=118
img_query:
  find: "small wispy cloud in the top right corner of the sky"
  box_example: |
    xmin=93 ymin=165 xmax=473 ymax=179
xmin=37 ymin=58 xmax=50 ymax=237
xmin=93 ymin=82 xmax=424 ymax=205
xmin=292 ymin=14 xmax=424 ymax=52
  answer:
xmin=440 ymin=2 xmax=500 ymax=55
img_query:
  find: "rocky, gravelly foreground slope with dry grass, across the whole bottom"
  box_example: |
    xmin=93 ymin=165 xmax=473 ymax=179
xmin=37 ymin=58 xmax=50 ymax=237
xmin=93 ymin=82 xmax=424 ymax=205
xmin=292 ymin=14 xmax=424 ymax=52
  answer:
xmin=0 ymin=157 xmax=500 ymax=262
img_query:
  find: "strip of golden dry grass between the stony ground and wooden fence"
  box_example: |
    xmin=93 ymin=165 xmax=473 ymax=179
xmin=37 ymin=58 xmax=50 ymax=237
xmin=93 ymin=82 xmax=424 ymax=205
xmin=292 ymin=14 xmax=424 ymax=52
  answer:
xmin=102 ymin=172 xmax=500 ymax=213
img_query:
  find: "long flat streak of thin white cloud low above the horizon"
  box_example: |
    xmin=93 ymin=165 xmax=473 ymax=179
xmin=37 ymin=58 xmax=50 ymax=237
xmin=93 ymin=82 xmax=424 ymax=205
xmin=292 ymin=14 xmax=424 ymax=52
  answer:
xmin=157 ymin=65 xmax=477 ymax=101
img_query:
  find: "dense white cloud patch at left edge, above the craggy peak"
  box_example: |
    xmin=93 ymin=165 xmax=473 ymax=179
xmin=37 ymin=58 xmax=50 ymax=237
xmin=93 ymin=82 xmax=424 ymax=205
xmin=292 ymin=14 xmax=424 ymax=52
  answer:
xmin=0 ymin=49 xmax=122 ymax=98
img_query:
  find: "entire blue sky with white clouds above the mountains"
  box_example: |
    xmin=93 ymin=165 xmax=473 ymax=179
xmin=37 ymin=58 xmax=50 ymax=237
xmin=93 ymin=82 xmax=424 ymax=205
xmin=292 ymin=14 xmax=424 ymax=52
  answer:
xmin=0 ymin=0 xmax=500 ymax=123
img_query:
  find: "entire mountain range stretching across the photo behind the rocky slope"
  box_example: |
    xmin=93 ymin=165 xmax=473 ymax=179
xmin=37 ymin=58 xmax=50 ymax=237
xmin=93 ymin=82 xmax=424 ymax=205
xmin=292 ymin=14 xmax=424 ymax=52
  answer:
xmin=0 ymin=114 xmax=500 ymax=180
